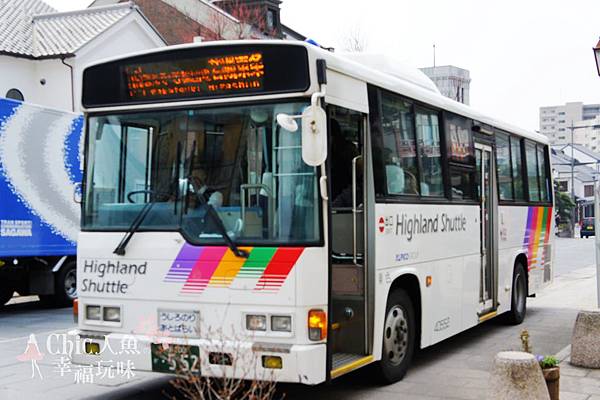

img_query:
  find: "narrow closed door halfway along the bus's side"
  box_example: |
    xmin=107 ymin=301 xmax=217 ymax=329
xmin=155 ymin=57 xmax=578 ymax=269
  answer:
xmin=475 ymin=143 xmax=498 ymax=318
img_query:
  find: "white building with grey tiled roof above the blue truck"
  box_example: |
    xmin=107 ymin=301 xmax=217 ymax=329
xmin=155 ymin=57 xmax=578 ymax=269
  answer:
xmin=0 ymin=0 xmax=165 ymax=111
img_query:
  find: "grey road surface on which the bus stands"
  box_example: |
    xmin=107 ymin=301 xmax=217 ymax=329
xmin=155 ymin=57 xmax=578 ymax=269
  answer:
xmin=0 ymin=239 xmax=595 ymax=400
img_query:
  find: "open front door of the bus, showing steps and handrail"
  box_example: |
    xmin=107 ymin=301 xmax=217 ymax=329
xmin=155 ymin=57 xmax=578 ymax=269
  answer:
xmin=328 ymin=105 xmax=370 ymax=378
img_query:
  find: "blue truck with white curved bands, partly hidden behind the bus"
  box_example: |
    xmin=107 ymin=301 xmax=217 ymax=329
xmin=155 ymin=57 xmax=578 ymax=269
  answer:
xmin=0 ymin=98 xmax=83 ymax=306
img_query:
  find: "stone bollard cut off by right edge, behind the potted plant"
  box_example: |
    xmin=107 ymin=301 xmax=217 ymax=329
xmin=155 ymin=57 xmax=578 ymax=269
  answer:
xmin=571 ymin=310 xmax=600 ymax=368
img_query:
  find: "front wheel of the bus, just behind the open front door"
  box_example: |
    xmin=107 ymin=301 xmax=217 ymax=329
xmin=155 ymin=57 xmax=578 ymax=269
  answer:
xmin=379 ymin=289 xmax=415 ymax=383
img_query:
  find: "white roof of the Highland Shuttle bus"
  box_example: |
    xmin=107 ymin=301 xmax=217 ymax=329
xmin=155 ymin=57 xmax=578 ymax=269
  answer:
xmin=82 ymin=40 xmax=548 ymax=144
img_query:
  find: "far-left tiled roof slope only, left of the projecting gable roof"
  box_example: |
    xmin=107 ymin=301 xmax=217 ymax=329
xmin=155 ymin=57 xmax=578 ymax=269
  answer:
xmin=0 ymin=0 xmax=56 ymax=56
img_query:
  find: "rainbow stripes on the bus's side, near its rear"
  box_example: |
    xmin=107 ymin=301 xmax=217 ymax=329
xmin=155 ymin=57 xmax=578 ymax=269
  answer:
xmin=523 ymin=207 xmax=552 ymax=270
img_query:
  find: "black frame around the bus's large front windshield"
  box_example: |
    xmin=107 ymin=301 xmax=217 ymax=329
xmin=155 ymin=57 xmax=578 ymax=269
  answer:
xmin=79 ymin=96 xmax=329 ymax=248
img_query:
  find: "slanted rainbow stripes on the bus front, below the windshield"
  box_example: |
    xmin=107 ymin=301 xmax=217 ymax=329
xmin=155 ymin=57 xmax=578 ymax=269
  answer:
xmin=164 ymin=243 xmax=304 ymax=294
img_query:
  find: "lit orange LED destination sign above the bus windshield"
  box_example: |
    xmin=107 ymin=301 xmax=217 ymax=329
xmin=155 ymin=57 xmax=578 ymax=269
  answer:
xmin=124 ymin=52 xmax=265 ymax=100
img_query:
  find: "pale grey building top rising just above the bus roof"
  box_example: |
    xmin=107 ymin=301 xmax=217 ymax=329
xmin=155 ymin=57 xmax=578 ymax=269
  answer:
xmin=421 ymin=65 xmax=471 ymax=105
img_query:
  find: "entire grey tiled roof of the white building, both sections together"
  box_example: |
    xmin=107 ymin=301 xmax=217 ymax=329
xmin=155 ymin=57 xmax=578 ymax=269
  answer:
xmin=0 ymin=0 xmax=136 ymax=58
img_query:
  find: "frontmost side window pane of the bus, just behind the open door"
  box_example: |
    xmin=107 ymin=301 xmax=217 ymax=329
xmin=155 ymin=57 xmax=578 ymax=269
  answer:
xmin=376 ymin=93 xmax=419 ymax=195
